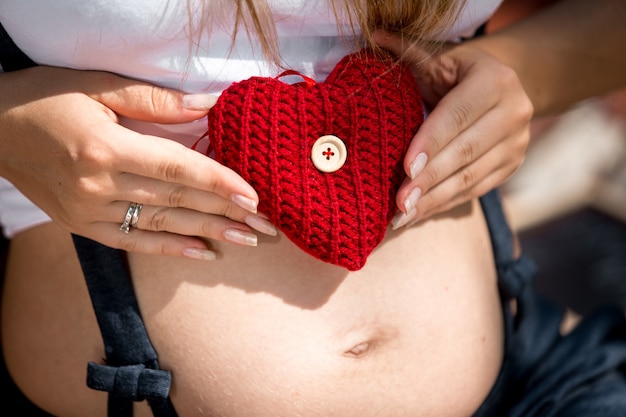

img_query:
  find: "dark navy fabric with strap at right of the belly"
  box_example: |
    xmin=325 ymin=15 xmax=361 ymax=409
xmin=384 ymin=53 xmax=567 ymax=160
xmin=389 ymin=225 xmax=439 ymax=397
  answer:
xmin=474 ymin=192 xmax=626 ymax=417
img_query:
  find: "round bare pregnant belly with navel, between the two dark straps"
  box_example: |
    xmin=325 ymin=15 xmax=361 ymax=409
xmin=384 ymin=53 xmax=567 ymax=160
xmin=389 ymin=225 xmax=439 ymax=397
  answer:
xmin=130 ymin=200 xmax=503 ymax=417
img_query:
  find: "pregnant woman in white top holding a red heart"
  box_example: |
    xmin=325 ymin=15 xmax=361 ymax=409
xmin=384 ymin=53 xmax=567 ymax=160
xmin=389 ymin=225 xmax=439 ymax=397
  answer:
xmin=0 ymin=0 xmax=626 ymax=417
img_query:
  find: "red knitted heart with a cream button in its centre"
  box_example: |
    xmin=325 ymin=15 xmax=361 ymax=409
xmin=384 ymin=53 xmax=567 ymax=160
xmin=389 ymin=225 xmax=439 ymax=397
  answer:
xmin=208 ymin=50 xmax=424 ymax=270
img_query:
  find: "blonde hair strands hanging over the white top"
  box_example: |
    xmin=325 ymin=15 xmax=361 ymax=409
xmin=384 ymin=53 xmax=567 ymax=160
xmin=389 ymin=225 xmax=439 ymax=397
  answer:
xmin=187 ymin=0 xmax=465 ymax=64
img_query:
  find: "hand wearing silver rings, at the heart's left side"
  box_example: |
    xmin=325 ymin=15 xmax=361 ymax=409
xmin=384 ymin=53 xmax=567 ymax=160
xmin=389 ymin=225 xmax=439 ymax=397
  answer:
xmin=0 ymin=67 xmax=275 ymax=259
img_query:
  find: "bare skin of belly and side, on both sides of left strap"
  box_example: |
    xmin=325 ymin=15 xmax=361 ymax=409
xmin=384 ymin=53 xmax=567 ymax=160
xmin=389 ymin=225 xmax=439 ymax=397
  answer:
xmin=0 ymin=201 xmax=504 ymax=417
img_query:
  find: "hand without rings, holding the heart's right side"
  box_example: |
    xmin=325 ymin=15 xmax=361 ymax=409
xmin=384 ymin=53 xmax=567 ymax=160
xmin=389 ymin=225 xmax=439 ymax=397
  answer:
xmin=376 ymin=33 xmax=533 ymax=228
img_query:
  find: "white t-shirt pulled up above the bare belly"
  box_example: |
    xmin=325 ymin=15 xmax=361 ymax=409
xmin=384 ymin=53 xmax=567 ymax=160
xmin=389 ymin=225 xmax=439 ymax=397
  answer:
xmin=0 ymin=0 xmax=502 ymax=237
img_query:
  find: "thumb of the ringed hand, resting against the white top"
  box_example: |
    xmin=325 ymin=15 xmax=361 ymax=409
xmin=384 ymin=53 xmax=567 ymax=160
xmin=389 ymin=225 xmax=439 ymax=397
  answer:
xmin=85 ymin=72 xmax=217 ymax=124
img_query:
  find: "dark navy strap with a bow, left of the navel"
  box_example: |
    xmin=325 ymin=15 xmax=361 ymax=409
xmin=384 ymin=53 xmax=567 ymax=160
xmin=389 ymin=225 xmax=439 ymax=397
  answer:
xmin=72 ymin=235 xmax=177 ymax=417
